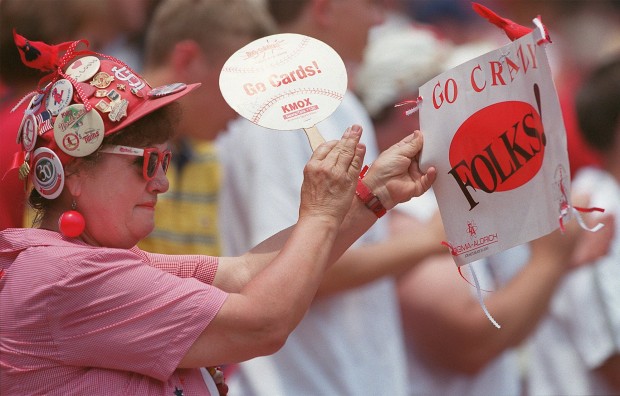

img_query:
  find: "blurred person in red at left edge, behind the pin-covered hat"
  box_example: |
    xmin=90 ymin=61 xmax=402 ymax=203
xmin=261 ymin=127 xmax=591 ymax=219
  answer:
xmin=0 ymin=0 xmax=79 ymax=230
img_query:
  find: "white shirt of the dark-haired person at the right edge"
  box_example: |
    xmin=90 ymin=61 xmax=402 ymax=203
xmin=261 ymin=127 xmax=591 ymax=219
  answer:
xmin=528 ymin=168 xmax=620 ymax=395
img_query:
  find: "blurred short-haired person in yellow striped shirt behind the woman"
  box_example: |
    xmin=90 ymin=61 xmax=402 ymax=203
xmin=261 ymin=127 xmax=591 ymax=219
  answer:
xmin=140 ymin=0 xmax=274 ymax=255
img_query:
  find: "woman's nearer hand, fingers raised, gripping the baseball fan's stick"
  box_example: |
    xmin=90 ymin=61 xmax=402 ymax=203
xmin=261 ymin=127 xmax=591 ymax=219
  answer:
xmin=299 ymin=125 xmax=366 ymax=222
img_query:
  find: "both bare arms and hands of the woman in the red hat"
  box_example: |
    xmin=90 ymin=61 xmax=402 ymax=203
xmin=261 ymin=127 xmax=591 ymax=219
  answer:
xmin=180 ymin=126 xmax=434 ymax=367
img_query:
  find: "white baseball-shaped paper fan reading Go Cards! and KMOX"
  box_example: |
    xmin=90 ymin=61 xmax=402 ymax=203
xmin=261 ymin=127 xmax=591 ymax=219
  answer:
xmin=220 ymin=33 xmax=347 ymax=150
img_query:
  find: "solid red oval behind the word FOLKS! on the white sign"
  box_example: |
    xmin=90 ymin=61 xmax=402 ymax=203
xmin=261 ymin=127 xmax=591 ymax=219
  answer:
xmin=450 ymin=101 xmax=546 ymax=193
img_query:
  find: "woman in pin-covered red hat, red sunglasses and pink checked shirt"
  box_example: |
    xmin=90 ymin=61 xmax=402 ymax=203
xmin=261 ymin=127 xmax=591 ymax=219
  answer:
xmin=0 ymin=36 xmax=435 ymax=395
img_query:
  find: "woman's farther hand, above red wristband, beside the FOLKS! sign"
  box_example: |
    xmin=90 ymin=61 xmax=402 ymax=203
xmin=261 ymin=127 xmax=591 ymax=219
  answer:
xmin=364 ymin=131 xmax=436 ymax=210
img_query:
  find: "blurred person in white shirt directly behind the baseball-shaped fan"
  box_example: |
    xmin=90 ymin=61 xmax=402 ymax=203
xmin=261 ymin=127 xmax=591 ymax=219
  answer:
xmin=218 ymin=0 xmax=443 ymax=395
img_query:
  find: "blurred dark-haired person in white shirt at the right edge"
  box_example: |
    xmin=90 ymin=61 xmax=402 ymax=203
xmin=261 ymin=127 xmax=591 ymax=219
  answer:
xmin=527 ymin=52 xmax=620 ymax=395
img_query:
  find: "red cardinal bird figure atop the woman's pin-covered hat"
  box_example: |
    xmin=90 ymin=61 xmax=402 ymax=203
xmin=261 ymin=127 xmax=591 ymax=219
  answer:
xmin=13 ymin=29 xmax=73 ymax=72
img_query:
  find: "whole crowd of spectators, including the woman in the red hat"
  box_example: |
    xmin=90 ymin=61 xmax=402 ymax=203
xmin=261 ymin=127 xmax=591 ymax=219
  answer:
xmin=0 ymin=0 xmax=620 ymax=396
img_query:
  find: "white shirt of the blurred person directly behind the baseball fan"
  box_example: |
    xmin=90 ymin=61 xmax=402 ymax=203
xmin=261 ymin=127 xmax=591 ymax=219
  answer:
xmin=218 ymin=93 xmax=407 ymax=396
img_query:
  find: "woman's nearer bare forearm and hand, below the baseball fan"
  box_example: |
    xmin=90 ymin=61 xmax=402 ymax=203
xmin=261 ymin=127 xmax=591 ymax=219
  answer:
xmin=180 ymin=127 xmax=365 ymax=367
